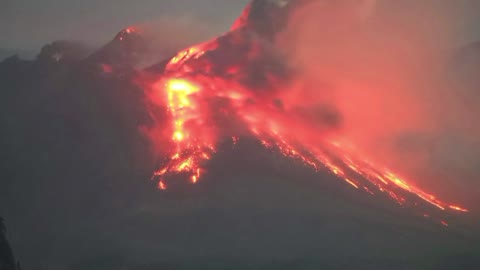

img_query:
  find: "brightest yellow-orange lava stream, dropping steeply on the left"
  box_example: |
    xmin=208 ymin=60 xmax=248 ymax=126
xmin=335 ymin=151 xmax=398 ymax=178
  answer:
xmin=154 ymin=48 xmax=215 ymax=189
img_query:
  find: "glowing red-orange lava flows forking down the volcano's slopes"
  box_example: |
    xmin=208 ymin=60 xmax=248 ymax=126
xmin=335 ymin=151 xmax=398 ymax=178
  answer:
xmin=143 ymin=0 xmax=468 ymax=226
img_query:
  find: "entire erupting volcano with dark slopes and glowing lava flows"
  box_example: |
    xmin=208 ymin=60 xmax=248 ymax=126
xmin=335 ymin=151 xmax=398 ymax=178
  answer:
xmin=0 ymin=0 xmax=479 ymax=270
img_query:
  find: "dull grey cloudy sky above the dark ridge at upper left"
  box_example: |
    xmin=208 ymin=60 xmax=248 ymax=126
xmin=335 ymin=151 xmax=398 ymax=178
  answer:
xmin=0 ymin=0 xmax=248 ymax=50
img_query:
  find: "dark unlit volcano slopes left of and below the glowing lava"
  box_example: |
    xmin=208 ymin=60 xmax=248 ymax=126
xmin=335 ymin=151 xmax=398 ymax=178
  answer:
xmin=0 ymin=1 xmax=479 ymax=270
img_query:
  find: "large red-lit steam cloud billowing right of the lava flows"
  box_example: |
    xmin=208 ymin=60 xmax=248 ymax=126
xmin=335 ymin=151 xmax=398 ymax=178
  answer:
xmin=276 ymin=0 xmax=480 ymax=204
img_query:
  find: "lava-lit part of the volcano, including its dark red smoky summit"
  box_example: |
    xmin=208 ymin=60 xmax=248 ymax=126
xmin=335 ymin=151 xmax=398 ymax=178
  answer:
xmin=137 ymin=1 xmax=468 ymax=226
